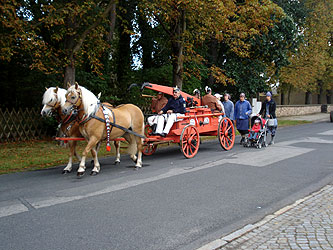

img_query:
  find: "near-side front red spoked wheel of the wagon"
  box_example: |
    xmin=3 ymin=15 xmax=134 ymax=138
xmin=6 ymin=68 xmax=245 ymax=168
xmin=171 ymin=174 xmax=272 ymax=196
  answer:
xmin=180 ymin=125 xmax=200 ymax=158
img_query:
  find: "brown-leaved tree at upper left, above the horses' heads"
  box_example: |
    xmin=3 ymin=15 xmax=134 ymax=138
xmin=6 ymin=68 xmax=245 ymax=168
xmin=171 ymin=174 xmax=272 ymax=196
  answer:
xmin=0 ymin=0 xmax=115 ymax=85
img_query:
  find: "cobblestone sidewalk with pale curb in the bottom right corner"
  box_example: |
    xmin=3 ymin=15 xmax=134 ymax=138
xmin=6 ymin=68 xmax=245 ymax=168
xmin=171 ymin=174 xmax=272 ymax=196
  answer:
xmin=200 ymin=185 xmax=333 ymax=250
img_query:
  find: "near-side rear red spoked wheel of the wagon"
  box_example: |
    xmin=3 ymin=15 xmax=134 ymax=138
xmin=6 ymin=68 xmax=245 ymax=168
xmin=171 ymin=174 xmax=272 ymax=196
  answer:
xmin=217 ymin=117 xmax=235 ymax=150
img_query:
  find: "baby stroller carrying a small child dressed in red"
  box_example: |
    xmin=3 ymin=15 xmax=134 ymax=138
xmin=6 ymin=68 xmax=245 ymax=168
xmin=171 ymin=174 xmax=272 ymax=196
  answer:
xmin=244 ymin=116 xmax=267 ymax=149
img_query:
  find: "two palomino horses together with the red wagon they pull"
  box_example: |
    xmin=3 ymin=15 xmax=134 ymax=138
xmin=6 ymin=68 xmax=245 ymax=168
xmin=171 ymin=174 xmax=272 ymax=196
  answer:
xmin=41 ymin=83 xmax=235 ymax=176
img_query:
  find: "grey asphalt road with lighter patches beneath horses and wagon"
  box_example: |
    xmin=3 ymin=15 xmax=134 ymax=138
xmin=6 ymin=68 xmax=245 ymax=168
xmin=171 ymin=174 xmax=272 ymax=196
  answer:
xmin=0 ymin=122 xmax=333 ymax=250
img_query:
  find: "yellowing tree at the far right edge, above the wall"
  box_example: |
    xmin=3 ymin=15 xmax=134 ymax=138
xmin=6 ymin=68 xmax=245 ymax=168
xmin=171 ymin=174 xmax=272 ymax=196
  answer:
xmin=280 ymin=0 xmax=333 ymax=103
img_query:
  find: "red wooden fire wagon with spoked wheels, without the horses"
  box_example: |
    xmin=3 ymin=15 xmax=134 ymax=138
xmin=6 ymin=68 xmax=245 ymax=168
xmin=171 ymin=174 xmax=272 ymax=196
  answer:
xmin=142 ymin=83 xmax=235 ymax=158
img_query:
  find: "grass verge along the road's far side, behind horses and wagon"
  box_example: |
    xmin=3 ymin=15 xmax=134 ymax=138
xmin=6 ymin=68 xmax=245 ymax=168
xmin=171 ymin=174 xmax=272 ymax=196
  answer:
xmin=0 ymin=120 xmax=311 ymax=174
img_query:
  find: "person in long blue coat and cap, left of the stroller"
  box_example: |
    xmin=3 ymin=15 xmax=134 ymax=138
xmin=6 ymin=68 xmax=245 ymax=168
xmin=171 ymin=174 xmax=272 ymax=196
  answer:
xmin=234 ymin=93 xmax=252 ymax=144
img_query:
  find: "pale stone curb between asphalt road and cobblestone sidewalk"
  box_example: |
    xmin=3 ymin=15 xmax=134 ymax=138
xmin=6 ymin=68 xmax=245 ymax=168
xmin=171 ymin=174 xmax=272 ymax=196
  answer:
xmin=197 ymin=184 xmax=332 ymax=250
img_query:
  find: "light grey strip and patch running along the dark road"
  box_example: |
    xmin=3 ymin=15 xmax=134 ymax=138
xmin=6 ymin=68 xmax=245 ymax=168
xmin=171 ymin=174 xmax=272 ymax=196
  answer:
xmin=0 ymin=137 xmax=326 ymax=218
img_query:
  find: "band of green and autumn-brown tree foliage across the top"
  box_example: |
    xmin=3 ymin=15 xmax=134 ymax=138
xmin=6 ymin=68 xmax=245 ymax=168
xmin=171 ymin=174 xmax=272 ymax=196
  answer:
xmin=0 ymin=0 xmax=333 ymax=107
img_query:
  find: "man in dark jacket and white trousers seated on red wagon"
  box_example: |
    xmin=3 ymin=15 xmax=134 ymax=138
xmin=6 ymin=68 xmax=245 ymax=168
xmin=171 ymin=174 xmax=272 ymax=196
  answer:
xmin=156 ymin=88 xmax=186 ymax=137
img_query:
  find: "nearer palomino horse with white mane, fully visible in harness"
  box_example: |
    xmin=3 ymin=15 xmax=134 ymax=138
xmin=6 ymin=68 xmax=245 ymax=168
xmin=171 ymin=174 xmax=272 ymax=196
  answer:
xmin=63 ymin=83 xmax=144 ymax=177
